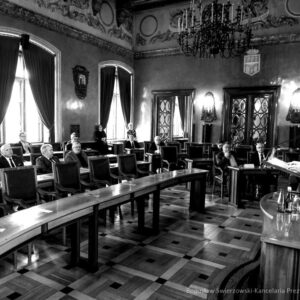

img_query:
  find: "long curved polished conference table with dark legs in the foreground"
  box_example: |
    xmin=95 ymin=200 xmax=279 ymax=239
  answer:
xmin=0 ymin=169 xmax=208 ymax=271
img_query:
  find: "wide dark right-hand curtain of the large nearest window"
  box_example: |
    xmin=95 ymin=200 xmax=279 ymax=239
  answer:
xmin=23 ymin=43 xmax=55 ymax=143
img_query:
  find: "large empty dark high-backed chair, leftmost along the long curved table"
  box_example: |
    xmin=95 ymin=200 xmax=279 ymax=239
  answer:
xmin=1 ymin=166 xmax=55 ymax=210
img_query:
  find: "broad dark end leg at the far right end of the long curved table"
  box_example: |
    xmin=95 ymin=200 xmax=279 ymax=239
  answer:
xmin=190 ymin=173 xmax=206 ymax=213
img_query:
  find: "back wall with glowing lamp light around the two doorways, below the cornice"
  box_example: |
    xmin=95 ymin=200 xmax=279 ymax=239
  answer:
xmin=134 ymin=43 xmax=300 ymax=145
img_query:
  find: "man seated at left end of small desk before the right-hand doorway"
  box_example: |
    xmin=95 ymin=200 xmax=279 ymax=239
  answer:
xmin=216 ymin=142 xmax=237 ymax=192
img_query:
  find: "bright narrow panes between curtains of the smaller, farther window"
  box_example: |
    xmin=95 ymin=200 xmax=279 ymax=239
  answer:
xmin=106 ymin=68 xmax=127 ymax=139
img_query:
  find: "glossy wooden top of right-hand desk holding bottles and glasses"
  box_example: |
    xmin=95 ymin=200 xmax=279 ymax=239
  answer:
xmin=260 ymin=192 xmax=300 ymax=249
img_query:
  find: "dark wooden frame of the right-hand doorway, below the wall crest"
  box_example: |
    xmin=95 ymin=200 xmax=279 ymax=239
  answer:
xmin=221 ymin=85 xmax=281 ymax=147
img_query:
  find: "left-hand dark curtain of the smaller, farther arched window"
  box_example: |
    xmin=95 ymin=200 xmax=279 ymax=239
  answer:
xmin=100 ymin=67 xmax=116 ymax=129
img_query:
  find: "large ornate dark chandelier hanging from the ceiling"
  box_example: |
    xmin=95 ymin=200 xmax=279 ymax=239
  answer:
xmin=178 ymin=0 xmax=252 ymax=58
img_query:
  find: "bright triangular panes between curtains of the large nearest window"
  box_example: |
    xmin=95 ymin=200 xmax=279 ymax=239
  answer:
xmin=1 ymin=52 xmax=49 ymax=143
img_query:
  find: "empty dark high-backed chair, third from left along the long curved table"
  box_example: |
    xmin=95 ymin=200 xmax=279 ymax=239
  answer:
xmin=88 ymin=156 xmax=123 ymax=221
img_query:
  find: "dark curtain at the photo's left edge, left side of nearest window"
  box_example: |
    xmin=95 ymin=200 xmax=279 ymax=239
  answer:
xmin=0 ymin=36 xmax=20 ymax=124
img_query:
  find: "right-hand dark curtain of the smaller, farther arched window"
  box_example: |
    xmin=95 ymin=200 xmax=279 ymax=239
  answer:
xmin=118 ymin=68 xmax=131 ymax=125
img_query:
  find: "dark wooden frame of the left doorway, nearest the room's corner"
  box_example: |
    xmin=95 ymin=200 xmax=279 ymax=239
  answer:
xmin=151 ymin=89 xmax=195 ymax=142
